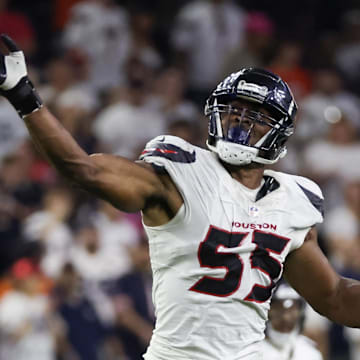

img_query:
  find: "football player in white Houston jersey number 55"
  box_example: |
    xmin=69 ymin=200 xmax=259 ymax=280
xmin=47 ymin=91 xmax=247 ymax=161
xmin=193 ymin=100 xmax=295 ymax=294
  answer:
xmin=0 ymin=35 xmax=360 ymax=360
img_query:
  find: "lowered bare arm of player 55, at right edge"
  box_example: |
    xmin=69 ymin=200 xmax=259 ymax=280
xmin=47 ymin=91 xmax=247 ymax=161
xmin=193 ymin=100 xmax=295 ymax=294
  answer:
xmin=284 ymin=228 xmax=360 ymax=327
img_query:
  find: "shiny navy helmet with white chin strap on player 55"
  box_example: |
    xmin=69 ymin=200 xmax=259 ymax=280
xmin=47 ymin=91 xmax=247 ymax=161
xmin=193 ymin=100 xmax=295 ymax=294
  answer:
xmin=205 ymin=68 xmax=297 ymax=165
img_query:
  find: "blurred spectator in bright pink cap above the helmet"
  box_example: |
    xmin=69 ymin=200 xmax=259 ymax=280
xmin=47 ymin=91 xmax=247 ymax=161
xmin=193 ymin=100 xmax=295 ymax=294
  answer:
xmin=220 ymin=12 xmax=275 ymax=78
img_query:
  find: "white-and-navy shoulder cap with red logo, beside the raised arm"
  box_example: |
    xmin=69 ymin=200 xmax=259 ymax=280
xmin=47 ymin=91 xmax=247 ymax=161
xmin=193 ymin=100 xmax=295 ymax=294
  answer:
xmin=140 ymin=135 xmax=196 ymax=164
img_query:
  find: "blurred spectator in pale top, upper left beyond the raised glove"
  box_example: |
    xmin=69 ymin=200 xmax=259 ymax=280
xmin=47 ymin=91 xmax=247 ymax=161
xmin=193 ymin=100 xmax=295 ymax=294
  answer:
xmin=63 ymin=0 xmax=129 ymax=90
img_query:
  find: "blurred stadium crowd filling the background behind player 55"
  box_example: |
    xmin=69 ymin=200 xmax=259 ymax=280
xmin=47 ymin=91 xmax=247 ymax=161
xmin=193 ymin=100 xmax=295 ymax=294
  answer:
xmin=0 ymin=0 xmax=360 ymax=360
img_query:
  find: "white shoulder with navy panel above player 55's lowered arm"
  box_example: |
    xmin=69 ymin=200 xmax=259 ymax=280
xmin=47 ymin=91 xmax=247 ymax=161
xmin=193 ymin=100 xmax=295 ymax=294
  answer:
xmin=265 ymin=170 xmax=324 ymax=214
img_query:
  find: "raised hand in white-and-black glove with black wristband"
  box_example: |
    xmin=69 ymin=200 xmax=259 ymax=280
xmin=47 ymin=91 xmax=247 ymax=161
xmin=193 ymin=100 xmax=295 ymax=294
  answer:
xmin=0 ymin=34 xmax=42 ymax=117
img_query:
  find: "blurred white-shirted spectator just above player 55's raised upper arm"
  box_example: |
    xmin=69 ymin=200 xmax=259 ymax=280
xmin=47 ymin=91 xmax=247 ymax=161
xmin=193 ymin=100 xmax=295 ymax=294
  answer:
xmin=93 ymin=58 xmax=165 ymax=159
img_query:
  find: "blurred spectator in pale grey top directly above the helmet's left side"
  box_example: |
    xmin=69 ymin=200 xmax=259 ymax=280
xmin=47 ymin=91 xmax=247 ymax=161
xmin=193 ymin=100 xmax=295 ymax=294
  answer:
xmin=171 ymin=0 xmax=246 ymax=106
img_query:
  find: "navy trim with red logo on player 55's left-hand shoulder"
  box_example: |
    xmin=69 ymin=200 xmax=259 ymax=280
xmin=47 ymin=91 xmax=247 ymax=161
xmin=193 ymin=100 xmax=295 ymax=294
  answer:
xmin=140 ymin=143 xmax=196 ymax=164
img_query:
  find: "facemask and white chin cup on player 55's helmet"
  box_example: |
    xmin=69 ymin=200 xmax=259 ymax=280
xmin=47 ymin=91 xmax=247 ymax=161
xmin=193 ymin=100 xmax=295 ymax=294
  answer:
xmin=205 ymin=98 xmax=293 ymax=165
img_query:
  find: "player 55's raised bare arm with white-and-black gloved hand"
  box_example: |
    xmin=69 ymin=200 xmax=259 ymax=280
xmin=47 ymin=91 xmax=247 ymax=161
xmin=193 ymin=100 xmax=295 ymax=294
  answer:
xmin=0 ymin=35 xmax=166 ymax=212
